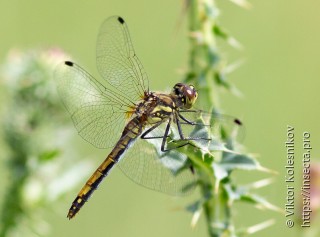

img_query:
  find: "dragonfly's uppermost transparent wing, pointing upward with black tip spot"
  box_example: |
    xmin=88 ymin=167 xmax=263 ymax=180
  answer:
xmin=96 ymin=16 xmax=149 ymax=102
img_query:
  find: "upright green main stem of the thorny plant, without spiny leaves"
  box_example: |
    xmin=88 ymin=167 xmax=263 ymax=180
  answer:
xmin=186 ymin=0 xmax=233 ymax=237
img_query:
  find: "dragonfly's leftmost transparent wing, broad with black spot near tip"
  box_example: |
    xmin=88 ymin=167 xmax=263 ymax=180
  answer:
xmin=54 ymin=62 xmax=134 ymax=148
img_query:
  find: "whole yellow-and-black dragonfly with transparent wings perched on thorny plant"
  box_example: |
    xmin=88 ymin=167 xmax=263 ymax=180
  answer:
xmin=55 ymin=16 xmax=241 ymax=219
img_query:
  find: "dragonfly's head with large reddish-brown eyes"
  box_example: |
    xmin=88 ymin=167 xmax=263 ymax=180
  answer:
xmin=172 ymin=83 xmax=198 ymax=109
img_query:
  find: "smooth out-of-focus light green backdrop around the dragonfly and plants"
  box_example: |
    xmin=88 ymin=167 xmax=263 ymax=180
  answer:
xmin=0 ymin=0 xmax=320 ymax=237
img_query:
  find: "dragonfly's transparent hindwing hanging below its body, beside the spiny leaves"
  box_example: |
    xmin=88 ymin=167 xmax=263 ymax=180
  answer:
xmin=118 ymin=125 xmax=196 ymax=195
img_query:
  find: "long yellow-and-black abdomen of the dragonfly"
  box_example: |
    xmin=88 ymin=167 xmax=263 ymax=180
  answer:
xmin=67 ymin=119 xmax=142 ymax=219
